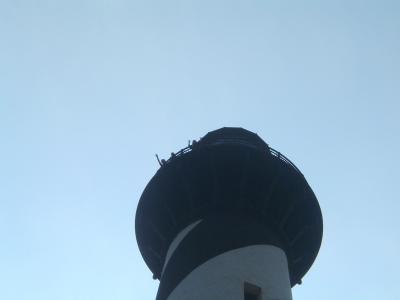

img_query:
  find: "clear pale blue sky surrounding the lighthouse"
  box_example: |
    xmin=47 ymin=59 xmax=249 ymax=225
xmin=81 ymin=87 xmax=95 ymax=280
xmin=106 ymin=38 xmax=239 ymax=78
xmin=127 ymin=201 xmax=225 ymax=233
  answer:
xmin=0 ymin=0 xmax=400 ymax=300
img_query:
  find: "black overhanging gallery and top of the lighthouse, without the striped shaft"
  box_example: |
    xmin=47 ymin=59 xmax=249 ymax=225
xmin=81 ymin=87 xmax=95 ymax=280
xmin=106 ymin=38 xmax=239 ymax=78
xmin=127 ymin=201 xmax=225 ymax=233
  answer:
xmin=135 ymin=128 xmax=323 ymax=286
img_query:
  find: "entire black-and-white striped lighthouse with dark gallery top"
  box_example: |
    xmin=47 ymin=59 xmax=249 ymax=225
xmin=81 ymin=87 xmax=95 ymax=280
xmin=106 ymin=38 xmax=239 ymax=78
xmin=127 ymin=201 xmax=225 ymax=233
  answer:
xmin=135 ymin=128 xmax=322 ymax=300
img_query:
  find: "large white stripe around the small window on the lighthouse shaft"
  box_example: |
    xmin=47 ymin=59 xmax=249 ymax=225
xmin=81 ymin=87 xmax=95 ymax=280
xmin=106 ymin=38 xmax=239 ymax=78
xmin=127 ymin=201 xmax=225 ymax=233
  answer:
xmin=167 ymin=245 xmax=292 ymax=300
